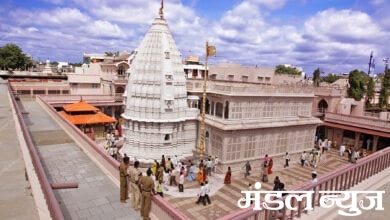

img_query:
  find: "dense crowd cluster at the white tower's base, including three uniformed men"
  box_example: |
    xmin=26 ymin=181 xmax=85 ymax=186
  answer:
xmin=119 ymin=154 xmax=218 ymax=219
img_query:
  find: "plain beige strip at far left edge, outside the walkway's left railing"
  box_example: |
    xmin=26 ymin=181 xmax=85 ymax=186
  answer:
xmin=0 ymin=83 xmax=39 ymax=220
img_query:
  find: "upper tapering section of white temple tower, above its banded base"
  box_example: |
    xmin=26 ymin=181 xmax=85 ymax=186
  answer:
xmin=122 ymin=18 xmax=187 ymax=121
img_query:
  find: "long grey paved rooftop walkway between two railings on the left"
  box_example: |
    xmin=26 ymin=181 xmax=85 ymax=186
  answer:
xmin=21 ymin=100 xmax=140 ymax=220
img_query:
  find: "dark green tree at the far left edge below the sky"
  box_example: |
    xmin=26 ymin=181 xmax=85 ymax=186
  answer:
xmin=0 ymin=44 xmax=33 ymax=70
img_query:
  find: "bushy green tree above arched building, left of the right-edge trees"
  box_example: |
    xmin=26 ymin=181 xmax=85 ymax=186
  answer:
xmin=348 ymin=69 xmax=367 ymax=101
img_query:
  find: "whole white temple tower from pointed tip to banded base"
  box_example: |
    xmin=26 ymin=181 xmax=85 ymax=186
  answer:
xmin=122 ymin=6 xmax=199 ymax=162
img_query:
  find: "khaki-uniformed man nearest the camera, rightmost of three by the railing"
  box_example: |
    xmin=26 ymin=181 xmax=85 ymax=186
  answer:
xmin=138 ymin=168 xmax=156 ymax=220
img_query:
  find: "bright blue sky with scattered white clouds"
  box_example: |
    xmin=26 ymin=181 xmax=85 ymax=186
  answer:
xmin=0 ymin=0 xmax=390 ymax=75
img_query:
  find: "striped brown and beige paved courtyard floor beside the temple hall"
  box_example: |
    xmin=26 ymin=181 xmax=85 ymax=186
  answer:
xmin=164 ymin=150 xmax=354 ymax=220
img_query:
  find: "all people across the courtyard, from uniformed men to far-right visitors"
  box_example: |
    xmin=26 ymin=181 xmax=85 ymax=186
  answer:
xmin=118 ymin=135 xmax=366 ymax=219
